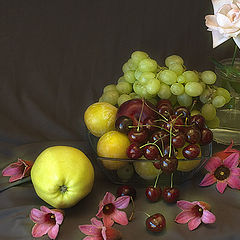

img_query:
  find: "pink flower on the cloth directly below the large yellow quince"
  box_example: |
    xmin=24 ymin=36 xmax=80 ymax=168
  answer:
xmin=30 ymin=206 xmax=63 ymax=239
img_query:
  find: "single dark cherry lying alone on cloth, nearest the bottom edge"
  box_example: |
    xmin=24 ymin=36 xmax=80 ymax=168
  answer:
xmin=146 ymin=213 xmax=166 ymax=232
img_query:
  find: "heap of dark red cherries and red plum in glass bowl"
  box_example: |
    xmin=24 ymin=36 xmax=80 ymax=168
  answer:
xmin=115 ymin=99 xmax=213 ymax=174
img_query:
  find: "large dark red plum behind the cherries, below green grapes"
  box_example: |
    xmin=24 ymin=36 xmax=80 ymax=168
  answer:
xmin=116 ymin=99 xmax=157 ymax=126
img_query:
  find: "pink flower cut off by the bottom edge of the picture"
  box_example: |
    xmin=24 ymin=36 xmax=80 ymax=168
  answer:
xmin=79 ymin=218 xmax=121 ymax=240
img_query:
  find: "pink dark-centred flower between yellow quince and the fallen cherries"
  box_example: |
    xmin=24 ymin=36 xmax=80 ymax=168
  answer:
xmin=96 ymin=192 xmax=130 ymax=227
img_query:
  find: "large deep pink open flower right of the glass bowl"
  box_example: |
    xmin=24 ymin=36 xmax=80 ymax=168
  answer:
xmin=199 ymin=152 xmax=240 ymax=193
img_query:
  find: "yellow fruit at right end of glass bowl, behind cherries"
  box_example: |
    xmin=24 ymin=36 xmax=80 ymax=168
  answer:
xmin=177 ymin=143 xmax=202 ymax=172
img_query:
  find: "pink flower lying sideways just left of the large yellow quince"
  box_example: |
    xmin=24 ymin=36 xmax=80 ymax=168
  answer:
xmin=2 ymin=158 xmax=33 ymax=182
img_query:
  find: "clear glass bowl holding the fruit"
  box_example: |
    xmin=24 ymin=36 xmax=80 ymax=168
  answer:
xmin=88 ymin=132 xmax=212 ymax=185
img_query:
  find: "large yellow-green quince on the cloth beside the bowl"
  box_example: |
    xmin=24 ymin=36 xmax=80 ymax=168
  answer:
xmin=31 ymin=146 xmax=94 ymax=208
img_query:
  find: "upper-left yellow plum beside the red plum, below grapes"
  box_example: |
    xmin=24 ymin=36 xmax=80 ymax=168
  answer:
xmin=84 ymin=102 xmax=117 ymax=137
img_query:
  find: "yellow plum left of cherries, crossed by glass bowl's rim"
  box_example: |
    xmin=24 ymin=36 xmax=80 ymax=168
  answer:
xmin=97 ymin=131 xmax=130 ymax=170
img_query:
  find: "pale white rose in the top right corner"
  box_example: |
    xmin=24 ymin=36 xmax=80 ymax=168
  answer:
xmin=205 ymin=0 xmax=240 ymax=48
